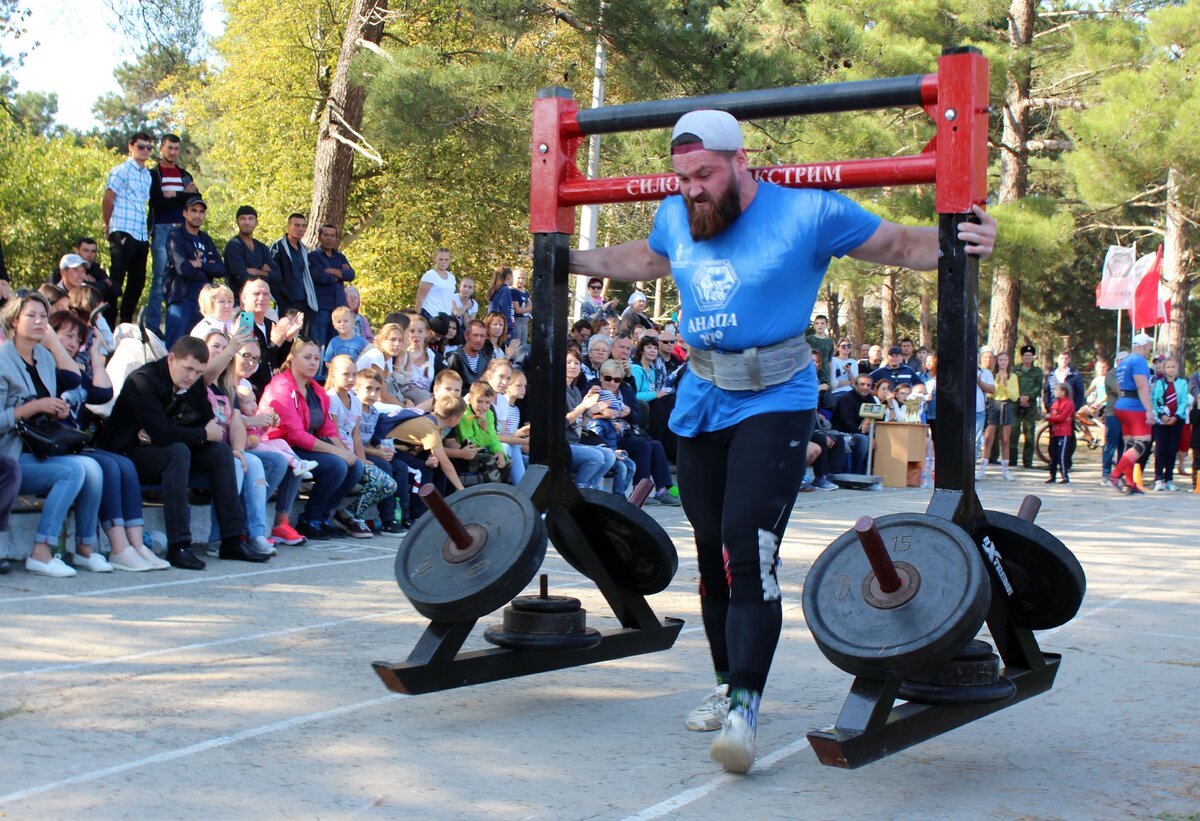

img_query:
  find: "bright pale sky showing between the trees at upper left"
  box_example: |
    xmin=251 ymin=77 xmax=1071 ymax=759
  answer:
xmin=5 ymin=0 xmax=222 ymax=131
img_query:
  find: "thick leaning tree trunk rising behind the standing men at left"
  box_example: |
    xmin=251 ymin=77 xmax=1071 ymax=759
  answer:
xmin=304 ymin=0 xmax=388 ymax=248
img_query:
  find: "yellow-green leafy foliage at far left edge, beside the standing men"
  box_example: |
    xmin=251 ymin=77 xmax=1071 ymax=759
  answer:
xmin=0 ymin=113 xmax=120 ymax=287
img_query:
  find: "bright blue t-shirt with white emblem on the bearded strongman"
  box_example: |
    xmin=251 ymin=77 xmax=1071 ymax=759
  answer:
xmin=649 ymin=182 xmax=880 ymax=436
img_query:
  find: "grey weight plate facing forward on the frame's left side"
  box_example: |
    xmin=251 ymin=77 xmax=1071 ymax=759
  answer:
xmin=396 ymin=484 xmax=546 ymax=622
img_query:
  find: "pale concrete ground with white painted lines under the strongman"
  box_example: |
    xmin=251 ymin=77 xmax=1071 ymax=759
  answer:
xmin=0 ymin=463 xmax=1200 ymax=820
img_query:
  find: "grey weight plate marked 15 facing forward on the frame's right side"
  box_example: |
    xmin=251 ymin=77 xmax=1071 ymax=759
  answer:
xmin=802 ymin=514 xmax=991 ymax=679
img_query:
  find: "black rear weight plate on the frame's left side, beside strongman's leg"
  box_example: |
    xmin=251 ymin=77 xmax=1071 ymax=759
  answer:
xmin=560 ymin=487 xmax=679 ymax=595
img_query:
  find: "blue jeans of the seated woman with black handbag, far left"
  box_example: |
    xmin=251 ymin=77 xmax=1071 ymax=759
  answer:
xmin=19 ymin=454 xmax=104 ymax=545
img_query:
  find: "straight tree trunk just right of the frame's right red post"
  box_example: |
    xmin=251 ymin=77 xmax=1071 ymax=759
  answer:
xmin=988 ymin=0 xmax=1037 ymax=353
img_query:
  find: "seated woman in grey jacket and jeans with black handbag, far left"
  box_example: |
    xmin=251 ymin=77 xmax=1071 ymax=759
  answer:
xmin=0 ymin=292 xmax=104 ymax=579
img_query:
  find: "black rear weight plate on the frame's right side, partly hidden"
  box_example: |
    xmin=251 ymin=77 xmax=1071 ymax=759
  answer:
xmin=980 ymin=510 xmax=1087 ymax=630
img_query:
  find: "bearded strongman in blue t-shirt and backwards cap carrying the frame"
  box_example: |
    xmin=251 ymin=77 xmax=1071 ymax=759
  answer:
xmin=570 ymin=105 xmax=996 ymax=773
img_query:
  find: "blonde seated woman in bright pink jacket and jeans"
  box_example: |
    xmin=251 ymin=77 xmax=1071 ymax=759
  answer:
xmin=266 ymin=337 xmax=362 ymax=541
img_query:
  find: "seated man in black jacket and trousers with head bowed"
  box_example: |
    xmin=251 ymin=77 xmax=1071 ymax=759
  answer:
xmin=97 ymin=336 xmax=263 ymax=570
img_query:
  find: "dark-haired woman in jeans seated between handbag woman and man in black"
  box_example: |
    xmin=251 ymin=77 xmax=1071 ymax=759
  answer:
xmin=50 ymin=311 xmax=170 ymax=573
